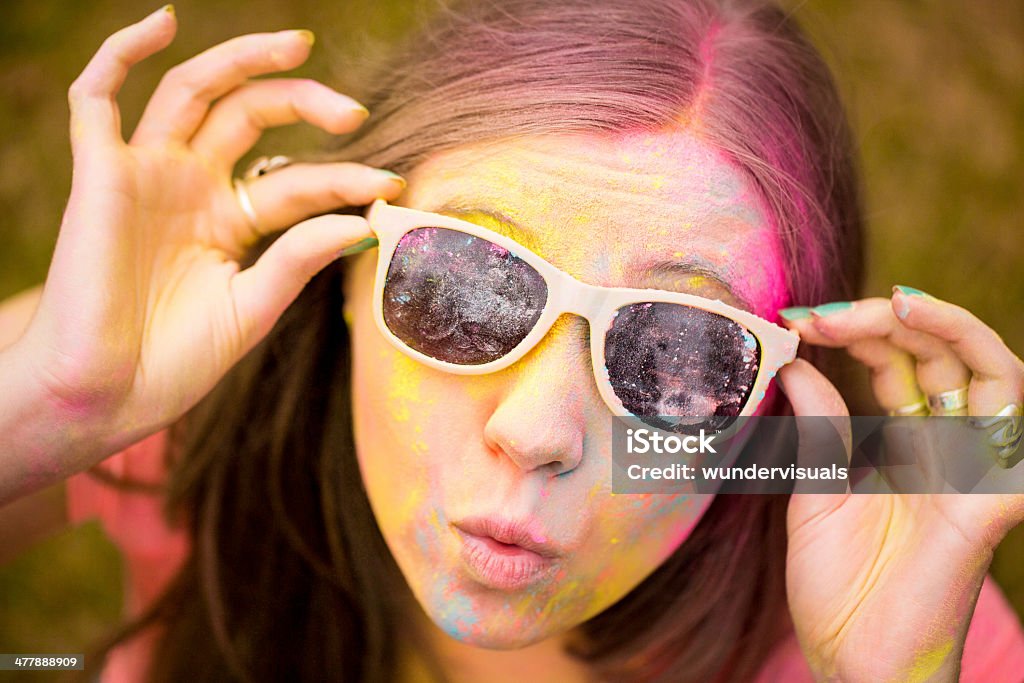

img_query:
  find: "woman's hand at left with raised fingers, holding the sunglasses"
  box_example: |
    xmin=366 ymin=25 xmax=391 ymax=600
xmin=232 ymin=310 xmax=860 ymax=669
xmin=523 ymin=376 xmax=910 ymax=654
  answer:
xmin=15 ymin=6 xmax=403 ymax=453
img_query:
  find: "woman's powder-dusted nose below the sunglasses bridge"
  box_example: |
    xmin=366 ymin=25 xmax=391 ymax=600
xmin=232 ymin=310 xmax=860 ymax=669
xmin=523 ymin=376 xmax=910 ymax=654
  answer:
xmin=483 ymin=314 xmax=601 ymax=475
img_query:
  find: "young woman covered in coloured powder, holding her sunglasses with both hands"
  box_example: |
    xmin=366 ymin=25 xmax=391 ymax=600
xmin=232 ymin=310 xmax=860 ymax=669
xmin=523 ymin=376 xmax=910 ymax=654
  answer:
xmin=0 ymin=0 xmax=1024 ymax=681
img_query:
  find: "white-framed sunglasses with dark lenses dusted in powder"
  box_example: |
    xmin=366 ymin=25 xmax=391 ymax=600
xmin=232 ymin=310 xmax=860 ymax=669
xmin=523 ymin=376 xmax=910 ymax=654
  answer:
xmin=366 ymin=200 xmax=800 ymax=429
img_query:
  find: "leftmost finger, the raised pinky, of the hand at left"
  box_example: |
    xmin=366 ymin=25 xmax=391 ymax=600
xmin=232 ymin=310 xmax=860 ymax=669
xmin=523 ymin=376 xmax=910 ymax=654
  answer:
xmin=68 ymin=5 xmax=177 ymax=152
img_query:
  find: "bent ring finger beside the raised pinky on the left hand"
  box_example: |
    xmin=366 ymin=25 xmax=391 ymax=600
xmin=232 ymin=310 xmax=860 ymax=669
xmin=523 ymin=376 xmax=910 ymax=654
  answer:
xmin=132 ymin=31 xmax=313 ymax=144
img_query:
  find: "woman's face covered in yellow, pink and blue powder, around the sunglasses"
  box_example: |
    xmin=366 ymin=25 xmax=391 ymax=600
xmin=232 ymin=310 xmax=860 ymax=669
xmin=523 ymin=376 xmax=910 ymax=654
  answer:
xmin=346 ymin=126 xmax=785 ymax=648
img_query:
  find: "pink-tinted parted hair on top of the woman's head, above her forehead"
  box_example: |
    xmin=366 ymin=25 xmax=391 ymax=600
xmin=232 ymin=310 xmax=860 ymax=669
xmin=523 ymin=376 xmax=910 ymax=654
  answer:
xmin=332 ymin=0 xmax=863 ymax=304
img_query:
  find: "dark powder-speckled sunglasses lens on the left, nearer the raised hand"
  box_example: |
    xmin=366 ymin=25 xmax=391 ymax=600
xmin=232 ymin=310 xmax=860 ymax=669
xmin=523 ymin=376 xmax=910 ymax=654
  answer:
xmin=384 ymin=227 xmax=548 ymax=366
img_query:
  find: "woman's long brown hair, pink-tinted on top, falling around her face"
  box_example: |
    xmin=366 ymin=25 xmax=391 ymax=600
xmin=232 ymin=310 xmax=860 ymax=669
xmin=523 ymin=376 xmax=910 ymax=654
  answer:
xmin=81 ymin=0 xmax=862 ymax=683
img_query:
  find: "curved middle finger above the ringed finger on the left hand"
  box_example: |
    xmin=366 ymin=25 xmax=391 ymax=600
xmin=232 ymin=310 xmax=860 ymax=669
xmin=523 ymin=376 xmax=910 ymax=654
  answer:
xmin=191 ymin=79 xmax=370 ymax=170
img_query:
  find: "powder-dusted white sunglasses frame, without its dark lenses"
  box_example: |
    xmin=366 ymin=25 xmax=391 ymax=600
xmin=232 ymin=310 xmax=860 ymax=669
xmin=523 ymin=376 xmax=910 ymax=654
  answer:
xmin=366 ymin=199 xmax=800 ymax=417
